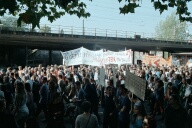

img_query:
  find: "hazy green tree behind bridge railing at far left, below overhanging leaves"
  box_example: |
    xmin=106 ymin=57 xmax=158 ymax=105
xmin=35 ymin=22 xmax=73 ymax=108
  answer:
xmin=0 ymin=16 xmax=29 ymax=31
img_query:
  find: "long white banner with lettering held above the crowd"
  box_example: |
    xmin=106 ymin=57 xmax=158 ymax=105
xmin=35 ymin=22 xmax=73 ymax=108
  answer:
xmin=62 ymin=47 xmax=132 ymax=66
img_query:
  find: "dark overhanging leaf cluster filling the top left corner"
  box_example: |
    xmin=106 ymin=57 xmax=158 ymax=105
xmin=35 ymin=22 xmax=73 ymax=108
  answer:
xmin=0 ymin=0 xmax=90 ymax=29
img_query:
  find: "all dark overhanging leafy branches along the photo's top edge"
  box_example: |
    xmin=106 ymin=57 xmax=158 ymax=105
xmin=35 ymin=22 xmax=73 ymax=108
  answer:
xmin=0 ymin=0 xmax=192 ymax=29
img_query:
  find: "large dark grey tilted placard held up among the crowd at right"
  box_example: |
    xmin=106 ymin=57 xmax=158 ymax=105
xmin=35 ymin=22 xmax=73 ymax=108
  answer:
xmin=125 ymin=71 xmax=146 ymax=100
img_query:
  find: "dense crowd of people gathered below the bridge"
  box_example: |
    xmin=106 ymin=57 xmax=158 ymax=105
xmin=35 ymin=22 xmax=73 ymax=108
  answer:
xmin=0 ymin=64 xmax=192 ymax=128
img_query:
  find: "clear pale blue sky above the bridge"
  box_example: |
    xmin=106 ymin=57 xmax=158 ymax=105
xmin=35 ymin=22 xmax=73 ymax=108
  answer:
xmin=40 ymin=0 xmax=192 ymax=37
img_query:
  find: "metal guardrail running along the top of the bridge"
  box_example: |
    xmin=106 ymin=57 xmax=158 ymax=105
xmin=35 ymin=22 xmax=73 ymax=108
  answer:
xmin=0 ymin=24 xmax=192 ymax=44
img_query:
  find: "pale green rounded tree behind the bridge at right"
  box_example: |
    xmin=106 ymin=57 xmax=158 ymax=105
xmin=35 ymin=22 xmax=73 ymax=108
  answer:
xmin=155 ymin=13 xmax=187 ymax=40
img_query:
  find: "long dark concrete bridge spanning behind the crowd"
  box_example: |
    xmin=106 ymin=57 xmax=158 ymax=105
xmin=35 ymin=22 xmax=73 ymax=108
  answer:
xmin=0 ymin=30 xmax=192 ymax=66
